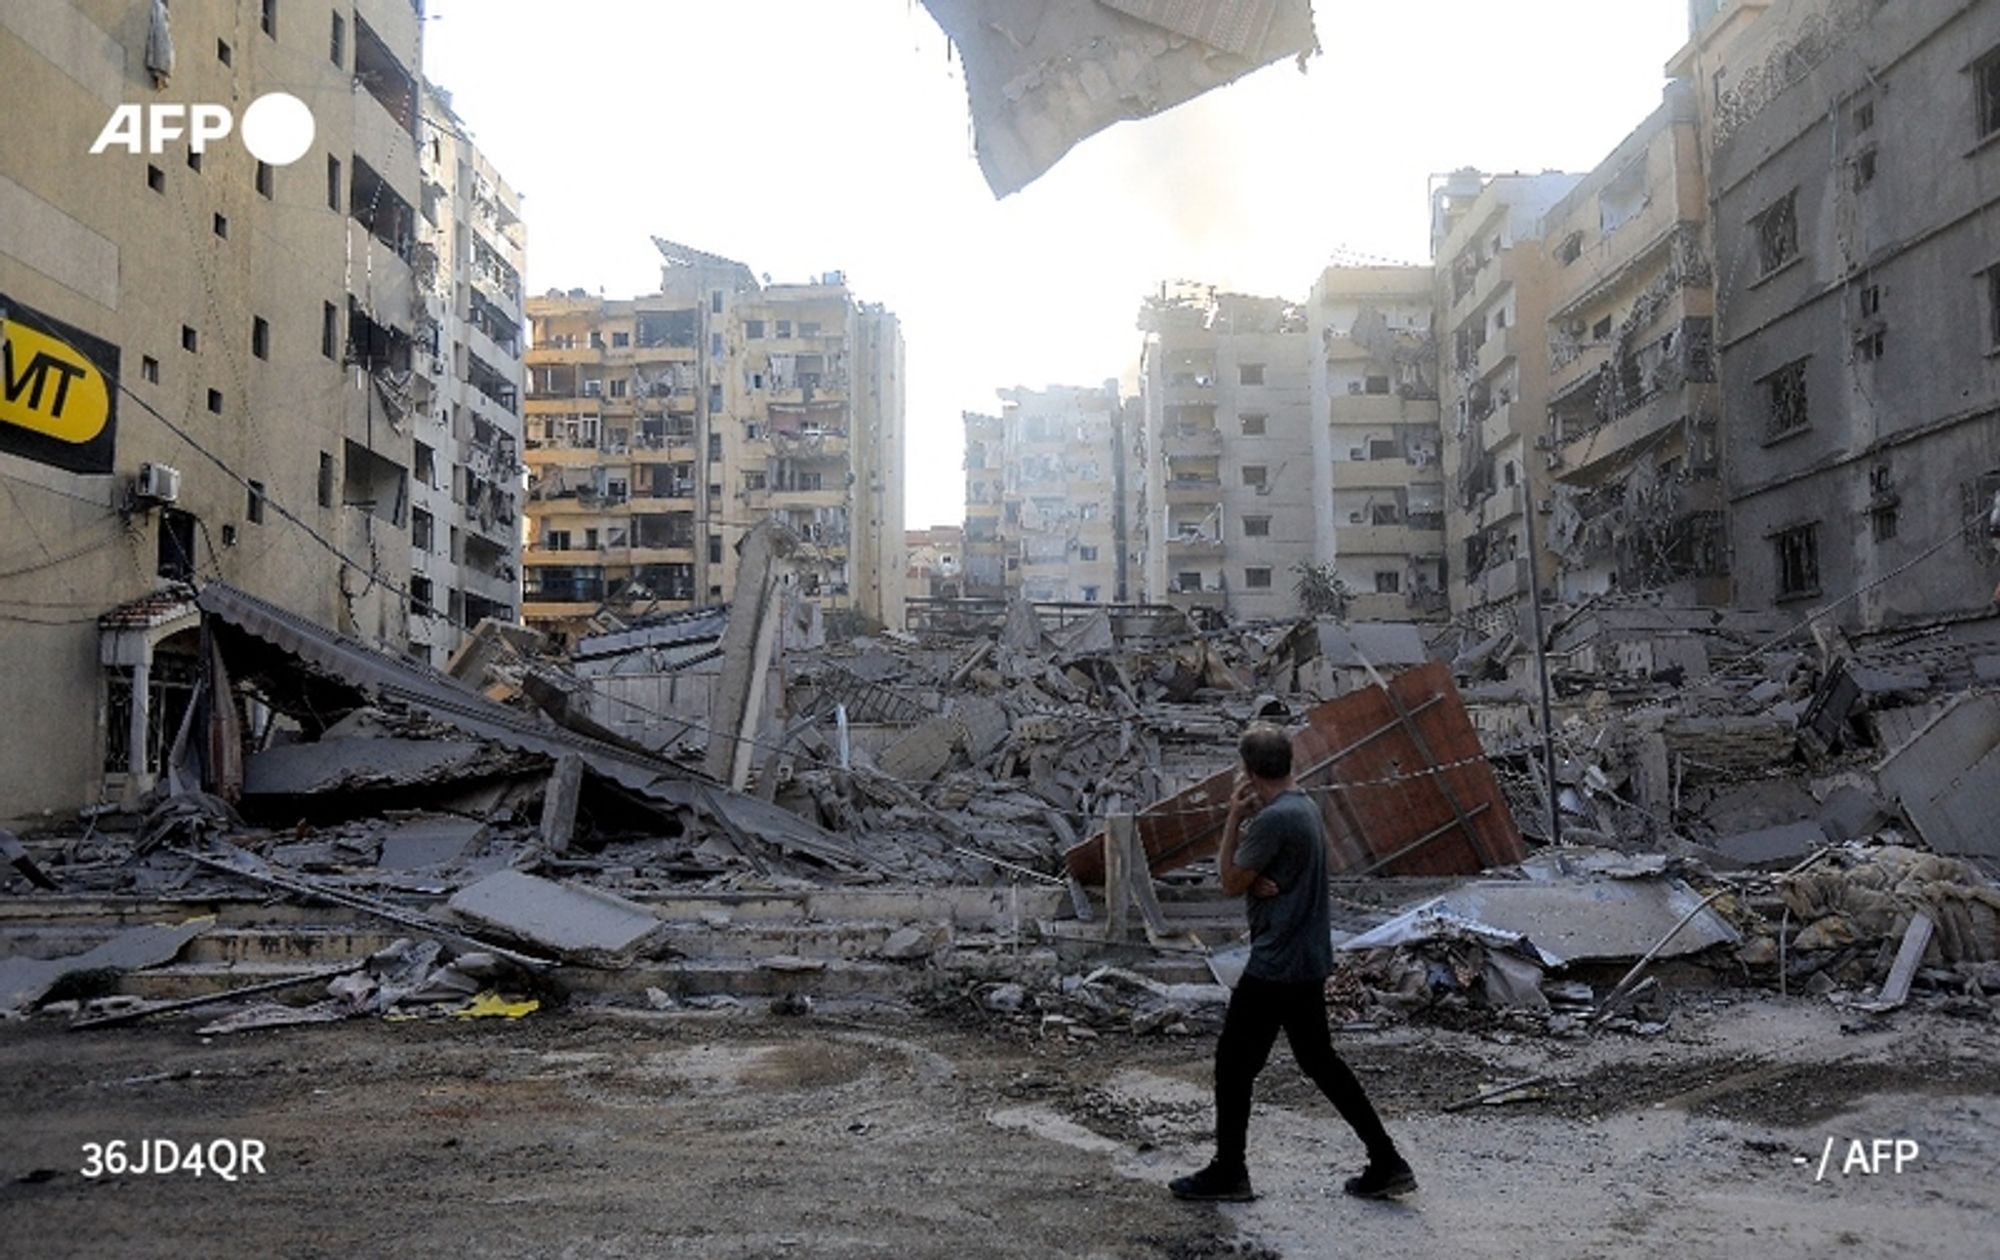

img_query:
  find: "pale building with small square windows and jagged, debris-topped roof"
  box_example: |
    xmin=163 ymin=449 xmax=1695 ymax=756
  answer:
xmin=1140 ymin=286 xmax=1320 ymax=620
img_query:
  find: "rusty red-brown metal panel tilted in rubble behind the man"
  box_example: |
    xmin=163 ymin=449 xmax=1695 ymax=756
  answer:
xmin=1064 ymin=662 xmax=1526 ymax=884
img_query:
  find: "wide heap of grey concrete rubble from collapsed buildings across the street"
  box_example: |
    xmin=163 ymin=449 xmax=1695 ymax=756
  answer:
xmin=0 ymin=584 xmax=2000 ymax=1040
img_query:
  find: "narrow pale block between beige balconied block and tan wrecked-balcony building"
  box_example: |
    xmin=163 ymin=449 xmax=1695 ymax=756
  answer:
xmin=1430 ymin=170 xmax=1580 ymax=628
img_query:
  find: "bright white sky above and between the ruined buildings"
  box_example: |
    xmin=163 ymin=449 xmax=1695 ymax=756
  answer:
xmin=424 ymin=0 xmax=1688 ymax=528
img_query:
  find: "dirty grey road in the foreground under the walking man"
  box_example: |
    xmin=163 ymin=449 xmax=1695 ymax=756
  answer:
xmin=0 ymin=1000 xmax=2000 ymax=1260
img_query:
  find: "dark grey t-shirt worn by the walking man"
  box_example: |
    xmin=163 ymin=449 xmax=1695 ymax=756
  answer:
xmin=1236 ymin=788 xmax=1334 ymax=984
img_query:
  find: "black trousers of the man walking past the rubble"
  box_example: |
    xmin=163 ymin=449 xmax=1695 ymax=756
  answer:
xmin=1216 ymin=976 xmax=1396 ymax=1168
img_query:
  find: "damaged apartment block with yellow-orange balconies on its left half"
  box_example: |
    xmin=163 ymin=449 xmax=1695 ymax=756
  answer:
xmin=524 ymin=238 xmax=906 ymax=638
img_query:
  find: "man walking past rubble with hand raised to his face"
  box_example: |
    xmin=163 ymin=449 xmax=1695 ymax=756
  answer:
xmin=1170 ymin=726 xmax=1416 ymax=1202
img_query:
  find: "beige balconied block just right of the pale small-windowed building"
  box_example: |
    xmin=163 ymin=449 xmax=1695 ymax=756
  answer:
xmin=1306 ymin=266 xmax=1446 ymax=622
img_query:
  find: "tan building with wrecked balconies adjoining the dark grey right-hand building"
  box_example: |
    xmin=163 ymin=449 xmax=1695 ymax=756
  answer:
xmin=1542 ymin=80 xmax=1728 ymax=606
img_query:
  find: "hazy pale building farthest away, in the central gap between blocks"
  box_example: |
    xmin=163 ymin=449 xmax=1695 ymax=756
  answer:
xmin=964 ymin=382 xmax=1128 ymax=604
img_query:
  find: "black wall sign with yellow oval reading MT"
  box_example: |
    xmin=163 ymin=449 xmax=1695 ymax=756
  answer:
xmin=0 ymin=294 xmax=118 ymax=474
